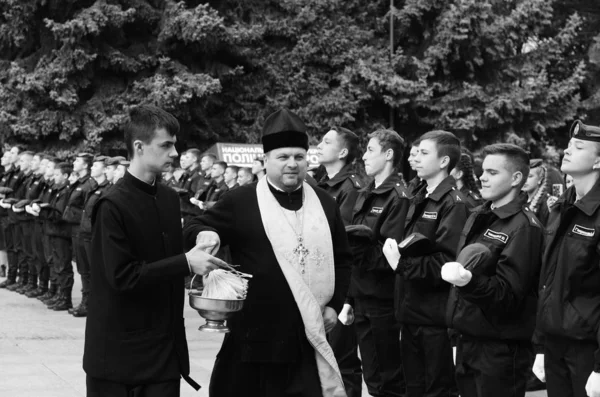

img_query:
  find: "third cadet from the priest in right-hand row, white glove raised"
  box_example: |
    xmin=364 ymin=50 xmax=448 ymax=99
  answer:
xmin=384 ymin=131 xmax=468 ymax=397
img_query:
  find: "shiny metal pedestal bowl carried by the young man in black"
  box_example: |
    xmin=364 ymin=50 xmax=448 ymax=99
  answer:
xmin=189 ymin=290 xmax=244 ymax=333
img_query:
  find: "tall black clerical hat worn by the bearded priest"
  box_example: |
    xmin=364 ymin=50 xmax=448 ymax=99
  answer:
xmin=262 ymin=108 xmax=308 ymax=153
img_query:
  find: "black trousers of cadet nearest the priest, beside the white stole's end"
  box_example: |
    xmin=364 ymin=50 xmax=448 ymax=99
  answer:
xmin=329 ymin=321 xmax=362 ymax=397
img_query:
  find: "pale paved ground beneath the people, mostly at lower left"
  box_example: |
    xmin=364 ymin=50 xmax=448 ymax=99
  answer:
xmin=0 ymin=270 xmax=546 ymax=397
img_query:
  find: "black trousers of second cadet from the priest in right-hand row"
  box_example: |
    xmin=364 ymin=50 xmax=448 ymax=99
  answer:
xmin=354 ymin=299 xmax=406 ymax=397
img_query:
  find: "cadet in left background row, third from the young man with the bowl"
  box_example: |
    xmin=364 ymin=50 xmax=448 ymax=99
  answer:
xmin=57 ymin=153 xmax=98 ymax=310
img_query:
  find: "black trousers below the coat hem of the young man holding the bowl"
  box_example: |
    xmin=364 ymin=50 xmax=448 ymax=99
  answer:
xmin=85 ymin=375 xmax=181 ymax=397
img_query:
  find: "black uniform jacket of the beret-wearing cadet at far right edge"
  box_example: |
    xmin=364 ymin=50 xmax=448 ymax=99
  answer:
xmin=537 ymin=182 xmax=600 ymax=371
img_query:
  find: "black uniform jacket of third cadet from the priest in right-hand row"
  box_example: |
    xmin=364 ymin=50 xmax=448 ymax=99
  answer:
xmin=396 ymin=176 xmax=468 ymax=327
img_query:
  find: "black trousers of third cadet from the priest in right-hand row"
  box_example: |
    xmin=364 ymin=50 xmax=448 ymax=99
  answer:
xmin=401 ymin=324 xmax=456 ymax=397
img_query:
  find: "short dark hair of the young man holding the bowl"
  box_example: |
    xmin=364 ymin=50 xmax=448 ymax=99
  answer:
xmin=123 ymin=105 xmax=179 ymax=158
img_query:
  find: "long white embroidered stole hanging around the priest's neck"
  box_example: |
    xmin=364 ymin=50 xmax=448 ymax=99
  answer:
xmin=256 ymin=178 xmax=346 ymax=397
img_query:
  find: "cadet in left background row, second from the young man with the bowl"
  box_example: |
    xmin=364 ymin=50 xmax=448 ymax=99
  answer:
xmin=70 ymin=156 xmax=110 ymax=317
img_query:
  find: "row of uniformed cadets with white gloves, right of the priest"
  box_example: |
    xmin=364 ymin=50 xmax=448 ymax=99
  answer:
xmin=319 ymin=122 xmax=600 ymax=397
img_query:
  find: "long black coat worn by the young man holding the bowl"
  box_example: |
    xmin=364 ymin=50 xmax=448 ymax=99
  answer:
xmin=83 ymin=172 xmax=189 ymax=385
